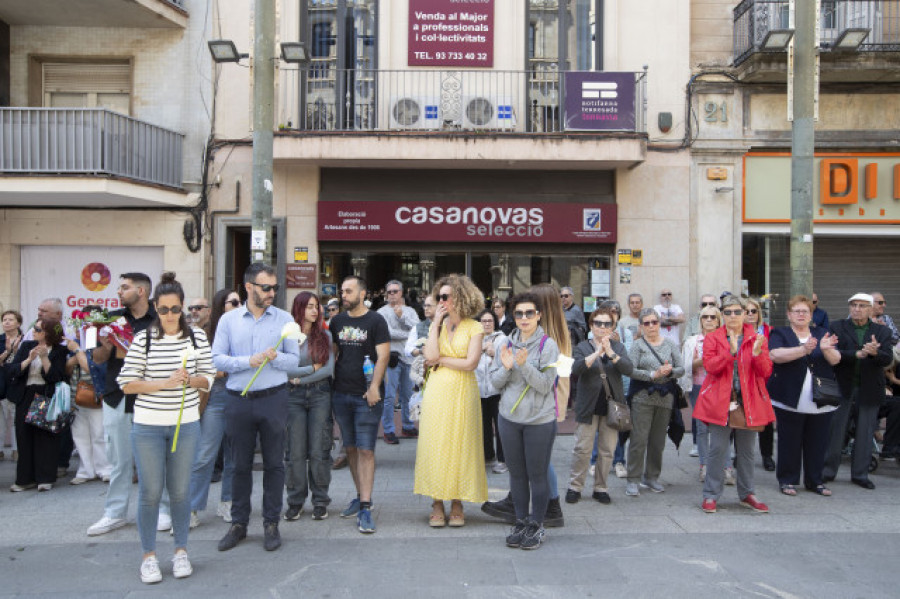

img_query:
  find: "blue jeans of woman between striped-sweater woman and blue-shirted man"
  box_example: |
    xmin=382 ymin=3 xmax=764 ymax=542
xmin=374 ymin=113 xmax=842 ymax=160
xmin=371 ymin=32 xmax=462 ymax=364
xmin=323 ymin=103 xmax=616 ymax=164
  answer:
xmin=191 ymin=379 xmax=234 ymax=512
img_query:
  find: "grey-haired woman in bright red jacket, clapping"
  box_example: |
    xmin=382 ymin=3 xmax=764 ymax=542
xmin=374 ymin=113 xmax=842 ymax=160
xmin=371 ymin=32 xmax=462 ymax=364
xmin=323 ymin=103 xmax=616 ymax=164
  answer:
xmin=694 ymin=295 xmax=775 ymax=513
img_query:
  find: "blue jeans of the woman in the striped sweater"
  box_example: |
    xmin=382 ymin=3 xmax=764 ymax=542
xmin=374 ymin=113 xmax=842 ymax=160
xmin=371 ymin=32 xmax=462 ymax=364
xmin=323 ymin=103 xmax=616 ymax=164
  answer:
xmin=131 ymin=422 xmax=200 ymax=553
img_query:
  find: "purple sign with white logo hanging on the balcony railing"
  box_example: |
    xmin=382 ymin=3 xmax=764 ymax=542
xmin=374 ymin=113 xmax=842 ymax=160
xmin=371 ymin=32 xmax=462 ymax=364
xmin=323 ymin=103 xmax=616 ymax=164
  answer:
xmin=565 ymin=71 xmax=635 ymax=131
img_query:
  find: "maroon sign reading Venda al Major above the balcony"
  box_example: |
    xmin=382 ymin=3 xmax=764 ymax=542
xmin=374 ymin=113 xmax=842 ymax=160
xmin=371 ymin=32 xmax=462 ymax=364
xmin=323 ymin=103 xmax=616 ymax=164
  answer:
xmin=407 ymin=0 xmax=494 ymax=68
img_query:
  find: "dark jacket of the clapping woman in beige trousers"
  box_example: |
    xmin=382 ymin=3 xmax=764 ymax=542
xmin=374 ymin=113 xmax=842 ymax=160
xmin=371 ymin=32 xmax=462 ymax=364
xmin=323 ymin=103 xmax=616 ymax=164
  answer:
xmin=572 ymin=341 xmax=634 ymax=424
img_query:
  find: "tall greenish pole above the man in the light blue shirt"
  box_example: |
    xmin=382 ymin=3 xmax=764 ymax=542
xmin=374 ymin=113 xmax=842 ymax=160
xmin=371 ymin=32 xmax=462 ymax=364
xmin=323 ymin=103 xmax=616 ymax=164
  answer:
xmin=250 ymin=0 xmax=275 ymax=266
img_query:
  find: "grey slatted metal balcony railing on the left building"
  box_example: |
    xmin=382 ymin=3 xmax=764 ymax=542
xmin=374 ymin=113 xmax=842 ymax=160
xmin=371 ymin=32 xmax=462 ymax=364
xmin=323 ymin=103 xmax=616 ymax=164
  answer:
xmin=0 ymin=108 xmax=184 ymax=188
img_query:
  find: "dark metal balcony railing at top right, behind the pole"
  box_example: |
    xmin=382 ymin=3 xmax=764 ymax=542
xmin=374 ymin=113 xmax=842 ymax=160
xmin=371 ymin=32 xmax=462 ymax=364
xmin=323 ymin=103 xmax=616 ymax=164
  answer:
xmin=734 ymin=0 xmax=900 ymax=65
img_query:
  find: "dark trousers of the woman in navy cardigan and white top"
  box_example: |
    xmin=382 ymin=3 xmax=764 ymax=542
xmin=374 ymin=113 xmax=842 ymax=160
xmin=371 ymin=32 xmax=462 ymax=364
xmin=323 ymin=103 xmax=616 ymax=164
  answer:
xmin=775 ymin=407 xmax=834 ymax=489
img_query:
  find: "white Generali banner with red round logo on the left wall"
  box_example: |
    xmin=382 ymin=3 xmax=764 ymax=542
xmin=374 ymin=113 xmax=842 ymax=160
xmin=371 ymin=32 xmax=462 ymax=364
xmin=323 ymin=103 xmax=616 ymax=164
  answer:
xmin=21 ymin=245 xmax=163 ymax=323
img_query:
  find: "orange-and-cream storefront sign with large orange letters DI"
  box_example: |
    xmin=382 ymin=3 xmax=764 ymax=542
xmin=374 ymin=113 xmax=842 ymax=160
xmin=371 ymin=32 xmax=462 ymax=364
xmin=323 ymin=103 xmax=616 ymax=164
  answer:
xmin=743 ymin=152 xmax=900 ymax=224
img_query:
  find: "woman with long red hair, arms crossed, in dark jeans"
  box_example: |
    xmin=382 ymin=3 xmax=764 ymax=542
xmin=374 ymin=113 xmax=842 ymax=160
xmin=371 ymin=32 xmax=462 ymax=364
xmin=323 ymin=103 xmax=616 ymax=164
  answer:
xmin=284 ymin=291 xmax=334 ymax=520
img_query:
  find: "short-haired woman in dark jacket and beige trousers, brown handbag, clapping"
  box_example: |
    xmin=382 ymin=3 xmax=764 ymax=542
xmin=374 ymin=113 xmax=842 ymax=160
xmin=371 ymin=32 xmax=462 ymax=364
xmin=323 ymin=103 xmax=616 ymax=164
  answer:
xmin=566 ymin=307 xmax=634 ymax=504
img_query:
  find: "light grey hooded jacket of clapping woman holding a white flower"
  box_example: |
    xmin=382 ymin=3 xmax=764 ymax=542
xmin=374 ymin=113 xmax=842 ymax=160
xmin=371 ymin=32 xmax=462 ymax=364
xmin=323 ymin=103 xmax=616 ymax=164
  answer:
xmin=491 ymin=326 xmax=559 ymax=424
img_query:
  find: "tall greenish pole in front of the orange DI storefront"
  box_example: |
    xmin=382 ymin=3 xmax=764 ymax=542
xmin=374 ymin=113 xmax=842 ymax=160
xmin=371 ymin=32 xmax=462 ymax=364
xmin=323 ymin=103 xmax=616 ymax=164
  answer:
xmin=788 ymin=0 xmax=819 ymax=297
